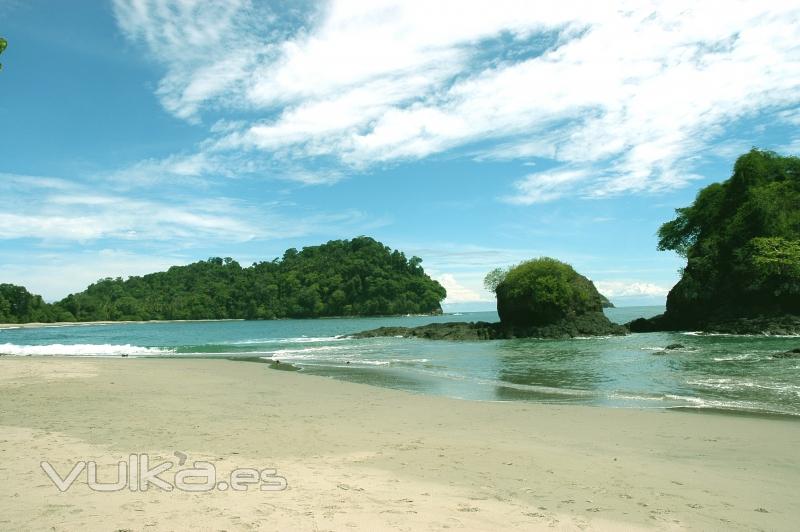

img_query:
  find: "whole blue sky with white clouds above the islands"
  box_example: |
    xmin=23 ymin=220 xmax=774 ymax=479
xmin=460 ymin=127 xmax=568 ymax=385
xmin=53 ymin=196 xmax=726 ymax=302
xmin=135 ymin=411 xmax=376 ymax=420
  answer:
xmin=0 ymin=0 xmax=800 ymax=310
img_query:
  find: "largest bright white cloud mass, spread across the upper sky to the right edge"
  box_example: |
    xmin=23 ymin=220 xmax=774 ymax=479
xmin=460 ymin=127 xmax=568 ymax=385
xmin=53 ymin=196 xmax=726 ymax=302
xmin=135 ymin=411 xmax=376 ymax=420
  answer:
xmin=114 ymin=0 xmax=800 ymax=203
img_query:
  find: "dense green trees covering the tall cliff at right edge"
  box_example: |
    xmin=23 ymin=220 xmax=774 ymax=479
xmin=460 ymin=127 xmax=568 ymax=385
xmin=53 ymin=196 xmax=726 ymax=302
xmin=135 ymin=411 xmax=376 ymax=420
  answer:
xmin=658 ymin=149 xmax=800 ymax=323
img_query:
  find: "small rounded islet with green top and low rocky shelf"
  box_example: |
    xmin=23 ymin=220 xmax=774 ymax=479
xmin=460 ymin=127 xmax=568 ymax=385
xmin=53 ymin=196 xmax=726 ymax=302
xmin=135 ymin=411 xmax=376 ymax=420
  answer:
xmin=353 ymin=258 xmax=628 ymax=340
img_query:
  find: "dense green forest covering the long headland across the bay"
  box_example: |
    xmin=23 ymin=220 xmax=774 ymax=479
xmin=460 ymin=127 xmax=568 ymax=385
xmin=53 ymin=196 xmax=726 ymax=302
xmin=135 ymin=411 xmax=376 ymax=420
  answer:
xmin=0 ymin=237 xmax=446 ymax=321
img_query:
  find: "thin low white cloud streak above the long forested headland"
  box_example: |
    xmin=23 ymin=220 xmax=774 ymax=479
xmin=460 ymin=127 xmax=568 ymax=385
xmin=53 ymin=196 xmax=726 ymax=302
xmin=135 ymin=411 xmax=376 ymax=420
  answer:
xmin=0 ymin=174 xmax=380 ymax=244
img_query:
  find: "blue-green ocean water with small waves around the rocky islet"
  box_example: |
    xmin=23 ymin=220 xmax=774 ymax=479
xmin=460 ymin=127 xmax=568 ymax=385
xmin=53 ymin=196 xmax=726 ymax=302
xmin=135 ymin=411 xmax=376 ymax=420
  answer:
xmin=0 ymin=307 xmax=800 ymax=416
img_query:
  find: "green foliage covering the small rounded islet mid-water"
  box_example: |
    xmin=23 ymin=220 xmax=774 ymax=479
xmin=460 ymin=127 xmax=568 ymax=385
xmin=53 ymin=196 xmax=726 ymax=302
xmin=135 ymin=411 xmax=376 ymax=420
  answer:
xmin=495 ymin=257 xmax=602 ymax=326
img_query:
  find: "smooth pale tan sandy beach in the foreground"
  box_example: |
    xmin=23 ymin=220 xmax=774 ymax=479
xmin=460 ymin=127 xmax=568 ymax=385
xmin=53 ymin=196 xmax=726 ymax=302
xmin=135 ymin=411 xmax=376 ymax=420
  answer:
xmin=0 ymin=356 xmax=800 ymax=531
